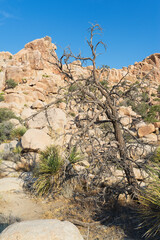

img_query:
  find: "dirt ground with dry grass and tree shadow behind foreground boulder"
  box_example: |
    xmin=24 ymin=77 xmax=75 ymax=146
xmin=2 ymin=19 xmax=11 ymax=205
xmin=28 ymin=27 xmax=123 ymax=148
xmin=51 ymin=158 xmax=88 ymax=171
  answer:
xmin=0 ymin=186 xmax=145 ymax=240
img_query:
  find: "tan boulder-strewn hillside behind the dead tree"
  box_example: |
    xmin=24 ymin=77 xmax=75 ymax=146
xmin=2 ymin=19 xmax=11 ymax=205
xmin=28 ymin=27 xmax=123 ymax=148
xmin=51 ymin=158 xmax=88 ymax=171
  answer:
xmin=0 ymin=37 xmax=160 ymax=174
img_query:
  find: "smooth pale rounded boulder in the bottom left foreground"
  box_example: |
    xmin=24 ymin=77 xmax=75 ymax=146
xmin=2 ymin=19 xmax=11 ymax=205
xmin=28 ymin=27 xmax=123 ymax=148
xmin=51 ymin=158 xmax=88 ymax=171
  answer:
xmin=0 ymin=219 xmax=83 ymax=240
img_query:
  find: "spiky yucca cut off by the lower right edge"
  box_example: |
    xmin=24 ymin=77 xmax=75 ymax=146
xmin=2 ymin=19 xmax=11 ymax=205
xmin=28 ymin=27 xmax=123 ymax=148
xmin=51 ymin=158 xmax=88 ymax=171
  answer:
xmin=139 ymin=149 xmax=160 ymax=239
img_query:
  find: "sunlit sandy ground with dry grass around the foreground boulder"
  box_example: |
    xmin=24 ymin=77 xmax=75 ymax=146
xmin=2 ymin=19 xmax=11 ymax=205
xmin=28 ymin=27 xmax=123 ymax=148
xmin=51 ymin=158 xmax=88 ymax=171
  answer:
xmin=0 ymin=179 xmax=138 ymax=240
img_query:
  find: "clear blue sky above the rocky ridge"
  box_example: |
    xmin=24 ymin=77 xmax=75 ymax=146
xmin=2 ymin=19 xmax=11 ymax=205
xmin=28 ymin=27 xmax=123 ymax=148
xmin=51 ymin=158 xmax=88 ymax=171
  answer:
xmin=0 ymin=0 xmax=160 ymax=68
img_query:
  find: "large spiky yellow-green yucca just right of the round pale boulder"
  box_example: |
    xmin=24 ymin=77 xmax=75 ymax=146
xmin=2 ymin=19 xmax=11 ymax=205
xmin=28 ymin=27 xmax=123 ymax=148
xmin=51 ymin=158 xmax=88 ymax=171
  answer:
xmin=34 ymin=146 xmax=63 ymax=195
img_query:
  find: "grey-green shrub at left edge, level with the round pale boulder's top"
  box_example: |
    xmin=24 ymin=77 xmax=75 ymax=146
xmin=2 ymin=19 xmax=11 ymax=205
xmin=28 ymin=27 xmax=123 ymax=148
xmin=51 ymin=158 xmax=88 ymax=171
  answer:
xmin=0 ymin=122 xmax=13 ymax=143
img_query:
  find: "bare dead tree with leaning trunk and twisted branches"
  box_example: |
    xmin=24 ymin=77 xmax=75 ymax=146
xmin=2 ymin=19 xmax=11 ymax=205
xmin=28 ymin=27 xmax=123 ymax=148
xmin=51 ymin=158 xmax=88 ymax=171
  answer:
xmin=51 ymin=24 xmax=146 ymax=198
